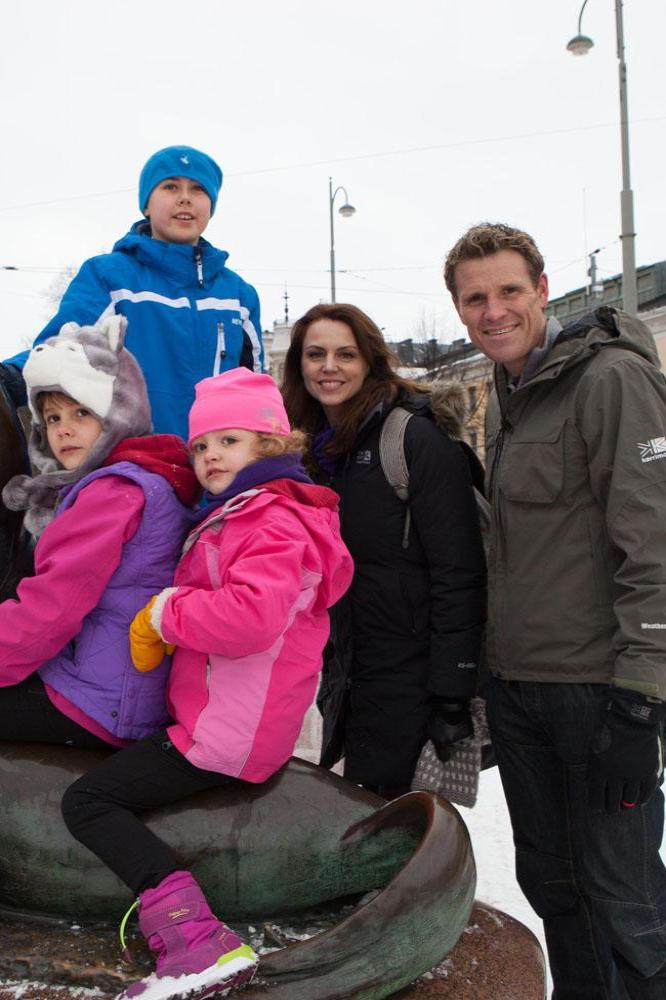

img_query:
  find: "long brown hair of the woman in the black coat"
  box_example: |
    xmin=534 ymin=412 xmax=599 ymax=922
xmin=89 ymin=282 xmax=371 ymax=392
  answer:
xmin=281 ymin=303 xmax=426 ymax=455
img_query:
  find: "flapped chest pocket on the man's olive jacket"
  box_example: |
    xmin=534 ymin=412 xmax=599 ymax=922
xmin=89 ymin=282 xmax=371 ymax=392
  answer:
xmin=498 ymin=435 xmax=564 ymax=504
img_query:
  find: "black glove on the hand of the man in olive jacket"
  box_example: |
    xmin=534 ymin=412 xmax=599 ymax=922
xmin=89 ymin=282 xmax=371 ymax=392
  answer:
xmin=588 ymin=688 xmax=666 ymax=814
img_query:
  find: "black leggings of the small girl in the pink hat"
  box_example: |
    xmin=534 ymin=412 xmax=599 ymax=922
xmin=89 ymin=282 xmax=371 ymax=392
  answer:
xmin=62 ymin=730 xmax=235 ymax=895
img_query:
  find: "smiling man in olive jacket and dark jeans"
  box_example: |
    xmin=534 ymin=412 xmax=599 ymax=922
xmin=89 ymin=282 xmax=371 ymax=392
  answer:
xmin=445 ymin=223 xmax=666 ymax=1000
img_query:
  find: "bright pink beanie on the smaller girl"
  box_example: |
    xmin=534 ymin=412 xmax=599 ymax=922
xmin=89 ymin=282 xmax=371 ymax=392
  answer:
xmin=188 ymin=368 xmax=291 ymax=445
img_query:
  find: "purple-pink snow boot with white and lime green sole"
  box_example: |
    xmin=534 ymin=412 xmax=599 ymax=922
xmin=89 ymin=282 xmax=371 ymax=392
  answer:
xmin=116 ymin=871 xmax=259 ymax=1000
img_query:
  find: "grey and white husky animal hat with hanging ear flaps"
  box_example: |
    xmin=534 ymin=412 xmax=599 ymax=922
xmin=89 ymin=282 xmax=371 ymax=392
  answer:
xmin=2 ymin=316 xmax=152 ymax=535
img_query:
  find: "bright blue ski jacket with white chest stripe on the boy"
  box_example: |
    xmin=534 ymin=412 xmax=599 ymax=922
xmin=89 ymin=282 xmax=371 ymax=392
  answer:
xmin=7 ymin=225 xmax=263 ymax=440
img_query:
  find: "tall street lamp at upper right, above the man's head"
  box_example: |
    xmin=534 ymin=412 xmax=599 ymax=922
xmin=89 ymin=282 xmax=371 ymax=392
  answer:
xmin=567 ymin=0 xmax=638 ymax=316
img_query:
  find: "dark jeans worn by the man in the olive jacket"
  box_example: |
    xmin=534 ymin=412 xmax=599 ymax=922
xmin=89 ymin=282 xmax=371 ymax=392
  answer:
xmin=488 ymin=678 xmax=666 ymax=1000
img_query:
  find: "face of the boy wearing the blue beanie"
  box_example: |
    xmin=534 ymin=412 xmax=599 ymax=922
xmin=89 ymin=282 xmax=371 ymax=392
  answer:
xmin=145 ymin=177 xmax=210 ymax=246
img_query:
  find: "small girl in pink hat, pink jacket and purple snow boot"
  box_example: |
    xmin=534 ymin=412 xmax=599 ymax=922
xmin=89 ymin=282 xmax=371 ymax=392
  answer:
xmin=63 ymin=368 xmax=353 ymax=1000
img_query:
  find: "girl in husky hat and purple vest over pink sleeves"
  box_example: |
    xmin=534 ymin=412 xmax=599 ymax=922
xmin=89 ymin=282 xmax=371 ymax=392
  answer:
xmin=0 ymin=316 xmax=198 ymax=748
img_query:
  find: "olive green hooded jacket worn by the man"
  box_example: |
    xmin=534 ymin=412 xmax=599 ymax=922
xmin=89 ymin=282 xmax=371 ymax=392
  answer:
xmin=486 ymin=308 xmax=666 ymax=700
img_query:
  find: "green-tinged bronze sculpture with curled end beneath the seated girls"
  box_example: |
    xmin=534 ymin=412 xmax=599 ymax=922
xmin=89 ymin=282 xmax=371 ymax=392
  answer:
xmin=0 ymin=743 xmax=475 ymax=1000
